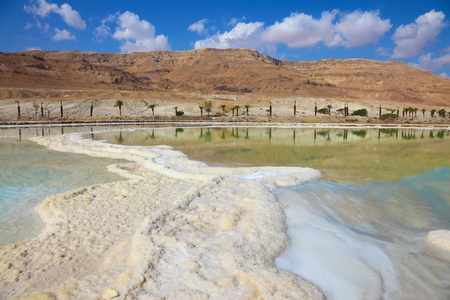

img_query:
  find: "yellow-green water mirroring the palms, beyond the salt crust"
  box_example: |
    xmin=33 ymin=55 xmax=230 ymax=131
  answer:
xmin=95 ymin=127 xmax=450 ymax=182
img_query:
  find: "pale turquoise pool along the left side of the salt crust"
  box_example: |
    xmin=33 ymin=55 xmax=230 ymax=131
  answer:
xmin=0 ymin=129 xmax=126 ymax=245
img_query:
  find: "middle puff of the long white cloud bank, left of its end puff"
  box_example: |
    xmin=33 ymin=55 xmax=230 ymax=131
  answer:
xmin=263 ymin=10 xmax=337 ymax=48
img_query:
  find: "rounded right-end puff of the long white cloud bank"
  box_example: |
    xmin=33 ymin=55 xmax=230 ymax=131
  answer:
xmin=335 ymin=10 xmax=392 ymax=48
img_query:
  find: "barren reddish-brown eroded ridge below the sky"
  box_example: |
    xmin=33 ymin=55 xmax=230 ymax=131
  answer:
xmin=0 ymin=49 xmax=450 ymax=106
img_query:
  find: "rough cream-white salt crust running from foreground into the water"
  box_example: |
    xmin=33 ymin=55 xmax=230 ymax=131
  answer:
xmin=0 ymin=134 xmax=324 ymax=299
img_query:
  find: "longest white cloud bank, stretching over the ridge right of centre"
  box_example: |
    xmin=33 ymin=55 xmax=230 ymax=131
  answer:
xmin=195 ymin=10 xmax=392 ymax=50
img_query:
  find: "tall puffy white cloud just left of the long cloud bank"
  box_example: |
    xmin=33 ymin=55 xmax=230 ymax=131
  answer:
xmin=112 ymin=11 xmax=170 ymax=52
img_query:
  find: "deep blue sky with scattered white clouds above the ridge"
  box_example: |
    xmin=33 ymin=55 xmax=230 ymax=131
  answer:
xmin=0 ymin=0 xmax=450 ymax=78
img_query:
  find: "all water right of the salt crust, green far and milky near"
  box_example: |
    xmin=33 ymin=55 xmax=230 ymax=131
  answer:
xmin=94 ymin=128 xmax=450 ymax=300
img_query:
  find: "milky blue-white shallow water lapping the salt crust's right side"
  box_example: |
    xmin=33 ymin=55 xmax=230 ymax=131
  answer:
xmin=276 ymin=168 xmax=450 ymax=299
